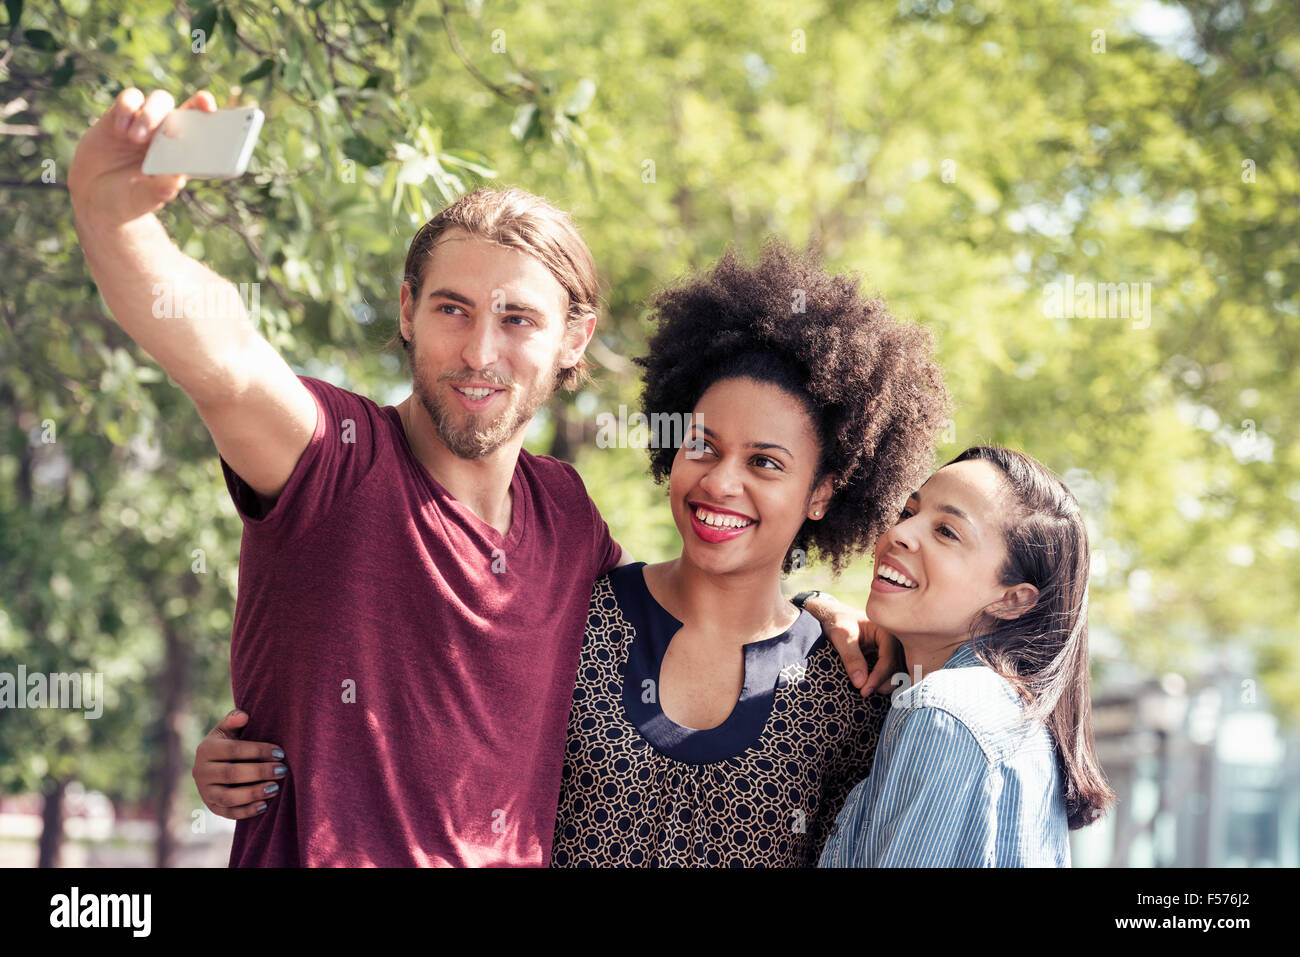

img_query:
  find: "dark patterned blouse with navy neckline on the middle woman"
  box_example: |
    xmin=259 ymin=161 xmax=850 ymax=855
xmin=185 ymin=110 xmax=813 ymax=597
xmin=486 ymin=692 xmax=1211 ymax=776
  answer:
xmin=551 ymin=563 xmax=889 ymax=867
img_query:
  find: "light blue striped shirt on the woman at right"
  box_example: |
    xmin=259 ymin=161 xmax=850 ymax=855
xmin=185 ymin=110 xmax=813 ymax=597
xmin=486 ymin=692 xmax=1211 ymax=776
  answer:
xmin=820 ymin=641 xmax=1070 ymax=867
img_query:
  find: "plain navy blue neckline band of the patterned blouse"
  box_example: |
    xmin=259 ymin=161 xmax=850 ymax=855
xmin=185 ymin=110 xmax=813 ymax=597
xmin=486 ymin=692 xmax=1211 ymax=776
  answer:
xmin=608 ymin=562 xmax=822 ymax=765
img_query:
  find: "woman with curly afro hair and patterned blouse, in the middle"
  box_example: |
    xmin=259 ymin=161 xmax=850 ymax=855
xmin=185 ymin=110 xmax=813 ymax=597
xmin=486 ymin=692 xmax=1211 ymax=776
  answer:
xmin=551 ymin=242 xmax=948 ymax=867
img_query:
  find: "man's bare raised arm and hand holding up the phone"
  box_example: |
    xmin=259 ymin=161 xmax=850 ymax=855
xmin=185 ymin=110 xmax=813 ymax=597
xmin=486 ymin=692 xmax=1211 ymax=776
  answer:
xmin=68 ymin=88 xmax=316 ymax=498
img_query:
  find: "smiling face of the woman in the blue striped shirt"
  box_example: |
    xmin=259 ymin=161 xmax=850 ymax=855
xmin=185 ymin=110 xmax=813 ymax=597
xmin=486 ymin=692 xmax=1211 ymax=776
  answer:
xmin=867 ymin=460 xmax=1035 ymax=641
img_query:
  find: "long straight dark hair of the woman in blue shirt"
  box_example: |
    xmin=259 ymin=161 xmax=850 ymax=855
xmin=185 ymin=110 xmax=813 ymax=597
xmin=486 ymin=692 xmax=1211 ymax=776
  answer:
xmin=948 ymin=446 xmax=1115 ymax=830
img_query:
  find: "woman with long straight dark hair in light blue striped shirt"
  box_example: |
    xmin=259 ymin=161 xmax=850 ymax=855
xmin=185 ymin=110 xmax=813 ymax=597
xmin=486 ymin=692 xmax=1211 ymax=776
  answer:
xmin=820 ymin=446 xmax=1114 ymax=867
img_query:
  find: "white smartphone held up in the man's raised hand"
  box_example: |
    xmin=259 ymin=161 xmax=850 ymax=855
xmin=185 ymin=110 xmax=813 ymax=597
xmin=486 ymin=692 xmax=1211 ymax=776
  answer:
xmin=140 ymin=107 xmax=263 ymax=179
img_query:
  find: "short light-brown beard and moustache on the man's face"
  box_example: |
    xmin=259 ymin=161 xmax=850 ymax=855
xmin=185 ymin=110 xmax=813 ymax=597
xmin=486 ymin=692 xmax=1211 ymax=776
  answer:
xmin=410 ymin=338 xmax=562 ymax=459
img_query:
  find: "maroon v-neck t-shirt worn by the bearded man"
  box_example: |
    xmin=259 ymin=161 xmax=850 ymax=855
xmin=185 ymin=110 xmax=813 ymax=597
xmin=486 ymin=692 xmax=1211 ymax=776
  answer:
xmin=222 ymin=377 xmax=619 ymax=866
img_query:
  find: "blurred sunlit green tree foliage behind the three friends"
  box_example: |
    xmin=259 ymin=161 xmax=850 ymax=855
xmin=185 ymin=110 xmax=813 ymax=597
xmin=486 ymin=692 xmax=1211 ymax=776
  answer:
xmin=0 ymin=0 xmax=1300 ymax=858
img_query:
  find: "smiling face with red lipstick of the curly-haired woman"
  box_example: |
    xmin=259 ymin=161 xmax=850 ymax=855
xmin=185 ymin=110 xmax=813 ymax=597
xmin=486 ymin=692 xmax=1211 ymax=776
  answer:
xmin=668 ymin=378 xmax=831 ymax=573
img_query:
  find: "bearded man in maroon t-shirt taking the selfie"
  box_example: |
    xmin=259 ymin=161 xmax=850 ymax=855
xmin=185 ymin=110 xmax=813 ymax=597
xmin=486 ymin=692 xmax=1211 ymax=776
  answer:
xmin=69 ymin=90 xmax=875 ymax=866
